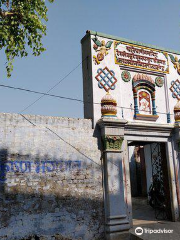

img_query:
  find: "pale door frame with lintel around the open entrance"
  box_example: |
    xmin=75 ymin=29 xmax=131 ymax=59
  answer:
xmin=124 ymin=123 xmax=179 ymax=223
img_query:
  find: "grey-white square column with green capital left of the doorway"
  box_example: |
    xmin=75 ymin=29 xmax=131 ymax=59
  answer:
xmin=98 ymin=118 xmax=132 ymax=240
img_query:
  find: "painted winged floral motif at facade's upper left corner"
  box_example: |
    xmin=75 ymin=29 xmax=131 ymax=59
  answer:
xmin=92 ymin=37 xmax=113 ymax=65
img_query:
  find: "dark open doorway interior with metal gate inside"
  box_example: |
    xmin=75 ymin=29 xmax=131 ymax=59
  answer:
xmin=129 ymin=142 xmax=172 ymax=224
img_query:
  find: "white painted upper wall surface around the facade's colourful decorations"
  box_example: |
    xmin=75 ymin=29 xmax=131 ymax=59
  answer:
xmin=82 ymin=34 xmax=180 ymax=125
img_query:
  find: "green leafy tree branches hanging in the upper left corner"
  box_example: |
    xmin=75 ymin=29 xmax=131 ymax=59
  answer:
xmin=0 ymin=0 xmax=54 ymax=77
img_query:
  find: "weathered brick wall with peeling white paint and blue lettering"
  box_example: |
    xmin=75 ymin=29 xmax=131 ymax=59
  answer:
xmin=0 ymin=113 xmax=104 ymax=240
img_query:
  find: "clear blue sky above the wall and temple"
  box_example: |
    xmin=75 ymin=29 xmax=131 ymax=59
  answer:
xmin=0 ymin=0 xmax=180 ymax=118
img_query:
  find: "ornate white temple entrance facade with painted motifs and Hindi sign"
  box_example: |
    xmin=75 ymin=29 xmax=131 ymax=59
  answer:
xmin=81 ymin=31 xmax=180 ymax=239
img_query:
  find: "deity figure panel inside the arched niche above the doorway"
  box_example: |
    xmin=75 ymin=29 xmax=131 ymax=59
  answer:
xmin=138 ymin=90 xmax=151 ymax=114
